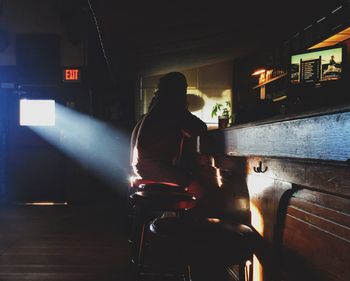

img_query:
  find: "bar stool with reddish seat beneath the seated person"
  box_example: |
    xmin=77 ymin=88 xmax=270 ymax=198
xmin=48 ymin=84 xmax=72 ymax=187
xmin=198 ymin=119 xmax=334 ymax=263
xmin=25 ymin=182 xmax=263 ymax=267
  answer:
xmin=130 ymin=183 xmax=196 ymax=277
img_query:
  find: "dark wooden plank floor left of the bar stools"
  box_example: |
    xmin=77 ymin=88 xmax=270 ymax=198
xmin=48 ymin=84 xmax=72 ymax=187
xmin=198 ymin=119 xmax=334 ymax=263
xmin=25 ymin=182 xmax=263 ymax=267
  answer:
xmin=0 ymin=205 xmax=131 ymax=281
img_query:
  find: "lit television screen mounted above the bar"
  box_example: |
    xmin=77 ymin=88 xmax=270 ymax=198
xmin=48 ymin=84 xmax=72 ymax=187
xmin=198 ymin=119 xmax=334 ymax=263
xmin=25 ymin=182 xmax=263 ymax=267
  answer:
xmin=290 ymin=47 xmax=343 ymax=84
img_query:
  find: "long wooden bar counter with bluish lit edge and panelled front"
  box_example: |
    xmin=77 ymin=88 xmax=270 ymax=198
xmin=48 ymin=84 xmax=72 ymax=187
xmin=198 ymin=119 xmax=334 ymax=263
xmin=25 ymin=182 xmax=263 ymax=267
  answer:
xmin=197 ymin=106 xmax=350 ymax=281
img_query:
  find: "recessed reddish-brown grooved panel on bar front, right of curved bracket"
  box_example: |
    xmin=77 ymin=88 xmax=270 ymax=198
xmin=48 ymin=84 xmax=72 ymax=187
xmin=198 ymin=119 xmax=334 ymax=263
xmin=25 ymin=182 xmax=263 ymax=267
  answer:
xmin=283 ymin=189 xmax=350 ymax=281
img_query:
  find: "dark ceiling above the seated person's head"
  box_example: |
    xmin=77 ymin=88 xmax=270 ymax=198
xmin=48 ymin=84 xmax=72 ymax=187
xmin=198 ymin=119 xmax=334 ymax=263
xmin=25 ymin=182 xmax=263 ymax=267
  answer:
xmin=89 ymin=0 xmax=348 ymax=75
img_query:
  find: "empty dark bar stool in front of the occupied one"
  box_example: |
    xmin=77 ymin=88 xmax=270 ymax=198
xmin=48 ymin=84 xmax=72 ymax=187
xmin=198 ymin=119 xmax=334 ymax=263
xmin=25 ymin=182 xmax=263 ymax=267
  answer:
xmin=150 ymin=217 xmax=255 ymax=281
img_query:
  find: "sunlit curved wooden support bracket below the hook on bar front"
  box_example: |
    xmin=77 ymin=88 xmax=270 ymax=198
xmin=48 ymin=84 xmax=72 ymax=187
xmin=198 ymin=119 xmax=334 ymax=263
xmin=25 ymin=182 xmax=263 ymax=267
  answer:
xmin=247 ymin=174 xmax=295 ymax=280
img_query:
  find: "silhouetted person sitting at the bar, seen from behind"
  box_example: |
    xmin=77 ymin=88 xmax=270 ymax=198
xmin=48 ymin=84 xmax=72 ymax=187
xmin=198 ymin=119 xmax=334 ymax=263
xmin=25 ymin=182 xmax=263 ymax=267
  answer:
xmin=131 ymin=72 xmax=207 ymax=185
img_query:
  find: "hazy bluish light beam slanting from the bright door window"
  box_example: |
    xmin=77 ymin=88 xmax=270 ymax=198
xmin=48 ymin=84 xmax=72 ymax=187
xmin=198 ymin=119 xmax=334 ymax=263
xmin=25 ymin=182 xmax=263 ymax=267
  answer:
xmin=30 ymin=103 xmax=129 ymax=191
